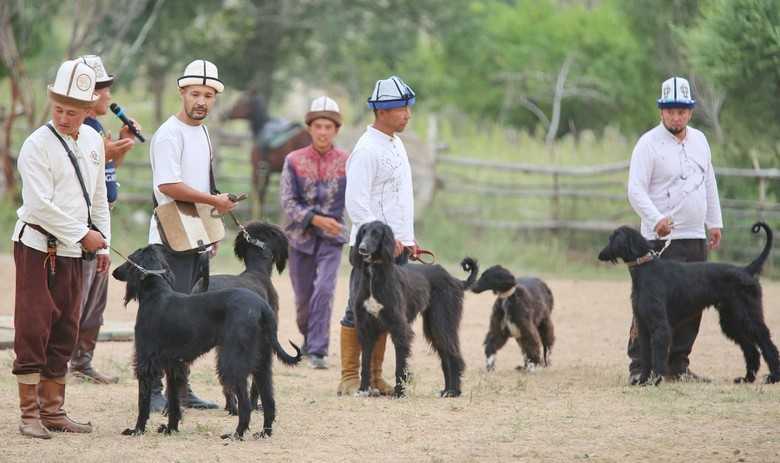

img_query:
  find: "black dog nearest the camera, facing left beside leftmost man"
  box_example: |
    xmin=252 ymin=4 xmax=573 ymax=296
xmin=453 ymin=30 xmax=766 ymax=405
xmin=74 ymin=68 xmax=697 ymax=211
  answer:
xmin=113 ymin=245 xmax=301 ymax=439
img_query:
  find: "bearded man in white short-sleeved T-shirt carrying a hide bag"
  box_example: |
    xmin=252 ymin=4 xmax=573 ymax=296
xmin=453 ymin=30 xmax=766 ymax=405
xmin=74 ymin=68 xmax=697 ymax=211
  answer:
xmin=149 ymin=59 xmax=235 ymax=411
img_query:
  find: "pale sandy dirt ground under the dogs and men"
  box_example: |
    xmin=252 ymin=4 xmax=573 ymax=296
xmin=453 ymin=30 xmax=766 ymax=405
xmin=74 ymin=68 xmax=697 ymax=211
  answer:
xmin=0 ymin=258 xmax=780 ymax=462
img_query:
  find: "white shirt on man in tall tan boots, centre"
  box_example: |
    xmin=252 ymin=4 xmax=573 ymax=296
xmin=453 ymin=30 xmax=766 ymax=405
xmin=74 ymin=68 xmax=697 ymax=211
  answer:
xmin=345 ymin=126 xmax=415 ymax=246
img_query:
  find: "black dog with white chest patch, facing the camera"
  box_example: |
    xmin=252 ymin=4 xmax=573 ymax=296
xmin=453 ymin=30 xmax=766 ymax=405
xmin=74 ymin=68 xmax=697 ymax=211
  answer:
xmin=350 ymin=221 xmax=479 ymax=397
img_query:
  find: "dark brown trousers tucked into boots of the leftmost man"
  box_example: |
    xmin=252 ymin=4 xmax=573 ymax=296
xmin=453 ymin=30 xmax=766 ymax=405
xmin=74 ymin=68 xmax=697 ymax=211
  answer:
xmin=13 ymin=242 xmax=83 ymax=378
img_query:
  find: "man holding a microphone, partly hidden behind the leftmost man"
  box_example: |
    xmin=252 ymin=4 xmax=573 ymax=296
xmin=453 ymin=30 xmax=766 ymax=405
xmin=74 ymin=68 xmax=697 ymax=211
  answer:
xmin=68 ymin=55 xmax=141 ymax=384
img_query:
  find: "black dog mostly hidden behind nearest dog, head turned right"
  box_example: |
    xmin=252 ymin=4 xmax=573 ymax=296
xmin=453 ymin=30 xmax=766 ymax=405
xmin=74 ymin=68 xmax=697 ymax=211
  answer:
xmin=193 ymin=221 xmax=289 ymax=415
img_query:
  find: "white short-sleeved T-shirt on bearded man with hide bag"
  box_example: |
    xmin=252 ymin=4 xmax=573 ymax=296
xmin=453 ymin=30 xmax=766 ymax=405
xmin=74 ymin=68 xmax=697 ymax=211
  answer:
xmin=149 ymin=115 xmax=211 ymax=244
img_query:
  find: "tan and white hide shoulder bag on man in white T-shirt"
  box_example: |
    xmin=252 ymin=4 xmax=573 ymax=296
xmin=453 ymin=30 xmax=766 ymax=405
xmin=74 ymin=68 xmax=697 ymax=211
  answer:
xmin=154 ymin=201 xmax=225 ymax=252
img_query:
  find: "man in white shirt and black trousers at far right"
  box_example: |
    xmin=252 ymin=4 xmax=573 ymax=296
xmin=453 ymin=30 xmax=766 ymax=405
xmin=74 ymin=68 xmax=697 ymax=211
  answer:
xmin=628 ymin=77 xmax=723 ymax=384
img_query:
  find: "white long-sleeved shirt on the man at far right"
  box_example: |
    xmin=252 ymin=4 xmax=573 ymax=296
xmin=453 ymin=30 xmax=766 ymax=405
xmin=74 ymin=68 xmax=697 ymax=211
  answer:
xmin=628 ymin=124 xmax=723 ymax=239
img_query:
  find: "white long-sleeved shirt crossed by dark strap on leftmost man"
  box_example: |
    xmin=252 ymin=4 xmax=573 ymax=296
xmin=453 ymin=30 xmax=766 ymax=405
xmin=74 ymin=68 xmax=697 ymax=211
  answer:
xmin=11 ymin=125 xmax=111 ymax=257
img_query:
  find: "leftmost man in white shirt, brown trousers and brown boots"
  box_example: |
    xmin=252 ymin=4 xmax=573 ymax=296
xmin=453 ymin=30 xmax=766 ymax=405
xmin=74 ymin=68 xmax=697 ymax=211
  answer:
xmin=12 ymin=60 xmax=111 ymax=439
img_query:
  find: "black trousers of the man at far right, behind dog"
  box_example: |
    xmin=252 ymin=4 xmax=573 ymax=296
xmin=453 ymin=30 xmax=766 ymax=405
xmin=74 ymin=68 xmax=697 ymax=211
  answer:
xmin=628 ymin=239 xmax=707 ymax=375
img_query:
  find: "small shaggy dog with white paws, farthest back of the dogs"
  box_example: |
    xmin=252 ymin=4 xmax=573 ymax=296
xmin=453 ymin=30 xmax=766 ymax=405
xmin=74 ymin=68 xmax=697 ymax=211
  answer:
xmin=471 ymin=265 xmax=555 ymax=371
